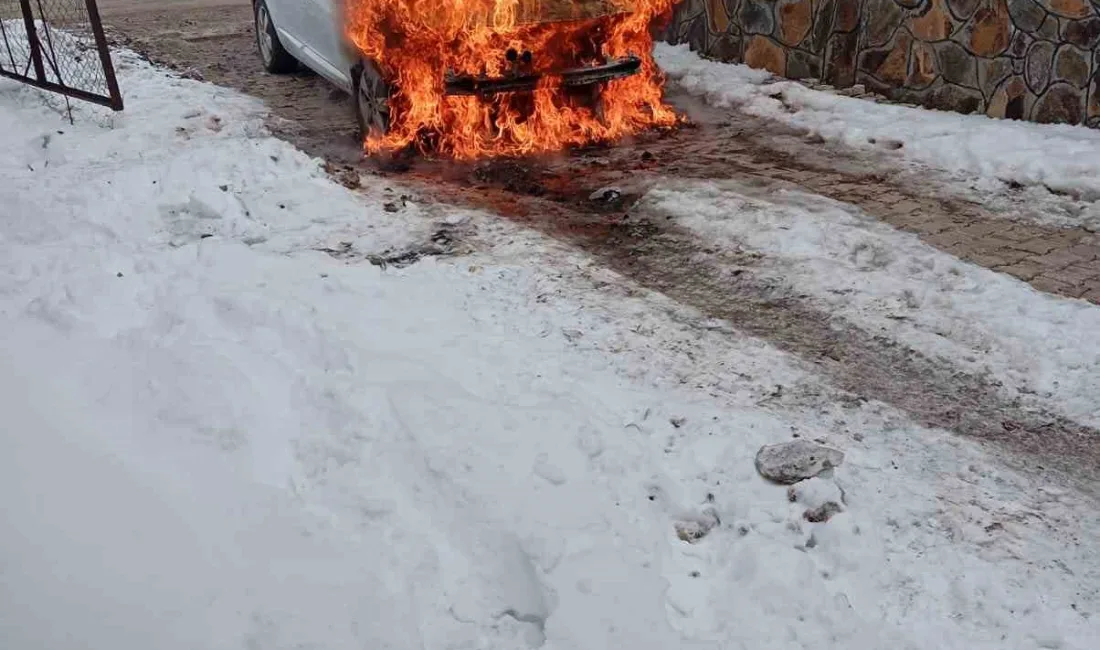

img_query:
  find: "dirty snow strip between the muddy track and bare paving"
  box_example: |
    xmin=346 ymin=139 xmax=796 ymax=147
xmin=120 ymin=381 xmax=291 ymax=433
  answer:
xmin=642 ymin=181 xmax=1100 ymax=427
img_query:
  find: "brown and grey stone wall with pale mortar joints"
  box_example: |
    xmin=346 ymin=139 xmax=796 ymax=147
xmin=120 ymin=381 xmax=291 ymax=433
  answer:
xmin=668 ymin=0 xmax=1100 ymax=126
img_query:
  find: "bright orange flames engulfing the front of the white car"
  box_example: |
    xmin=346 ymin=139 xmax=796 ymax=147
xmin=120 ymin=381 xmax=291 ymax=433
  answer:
xmin=345 ymin=0 xmax=678 ymax=158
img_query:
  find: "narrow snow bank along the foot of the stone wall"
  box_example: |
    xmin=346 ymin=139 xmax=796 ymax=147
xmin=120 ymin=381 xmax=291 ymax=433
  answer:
xmin=656 ymin=43 xmax=1100 ymax=201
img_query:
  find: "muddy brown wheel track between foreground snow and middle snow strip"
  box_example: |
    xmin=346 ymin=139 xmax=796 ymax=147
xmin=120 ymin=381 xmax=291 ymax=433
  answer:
xmin=396 ymin=173 xmax=1100 ymax=494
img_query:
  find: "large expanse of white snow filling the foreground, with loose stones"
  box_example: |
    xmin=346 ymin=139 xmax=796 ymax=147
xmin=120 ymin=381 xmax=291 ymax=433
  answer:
xmin=0 ymin=48 xmax=1100 ymax=650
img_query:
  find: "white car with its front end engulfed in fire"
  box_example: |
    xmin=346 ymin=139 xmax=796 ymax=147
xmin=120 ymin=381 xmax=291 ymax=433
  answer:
xmin=253 ymin=0 xmax=677 ymax=158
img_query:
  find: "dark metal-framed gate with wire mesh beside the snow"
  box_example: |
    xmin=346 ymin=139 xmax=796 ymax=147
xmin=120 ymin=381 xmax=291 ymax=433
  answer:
xmin=0 ymin=0 xmax=122 ymax=111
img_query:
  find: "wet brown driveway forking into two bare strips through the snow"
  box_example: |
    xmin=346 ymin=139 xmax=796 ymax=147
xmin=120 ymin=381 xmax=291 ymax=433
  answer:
xmin=100 ymin=0 xmax=1100 ymax=485
